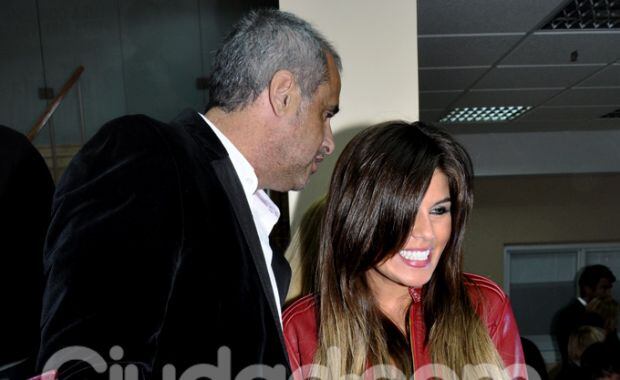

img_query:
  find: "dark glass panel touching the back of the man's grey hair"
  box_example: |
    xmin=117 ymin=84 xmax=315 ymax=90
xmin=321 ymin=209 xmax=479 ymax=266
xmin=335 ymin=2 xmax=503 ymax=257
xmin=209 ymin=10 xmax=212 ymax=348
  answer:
xmin=120 ymin=0 xmax=204 ymax=121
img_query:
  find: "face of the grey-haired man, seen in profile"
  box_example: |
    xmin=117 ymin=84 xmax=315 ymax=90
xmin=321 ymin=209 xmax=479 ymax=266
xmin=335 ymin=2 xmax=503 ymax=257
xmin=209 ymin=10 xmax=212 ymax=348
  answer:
xmin=272 ymin=56 xmax=340 ymax=191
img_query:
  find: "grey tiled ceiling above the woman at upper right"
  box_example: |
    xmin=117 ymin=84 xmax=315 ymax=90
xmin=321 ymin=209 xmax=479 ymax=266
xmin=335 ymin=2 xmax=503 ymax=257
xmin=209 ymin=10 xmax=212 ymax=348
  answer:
xmin=418 ymin=0 xmax=620 ymax=133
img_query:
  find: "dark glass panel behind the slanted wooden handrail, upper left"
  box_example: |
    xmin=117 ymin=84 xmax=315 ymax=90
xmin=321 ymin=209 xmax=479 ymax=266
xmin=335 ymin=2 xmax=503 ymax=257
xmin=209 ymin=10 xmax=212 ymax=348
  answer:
xmin=39 ymin=0 xmax=126 ymax=145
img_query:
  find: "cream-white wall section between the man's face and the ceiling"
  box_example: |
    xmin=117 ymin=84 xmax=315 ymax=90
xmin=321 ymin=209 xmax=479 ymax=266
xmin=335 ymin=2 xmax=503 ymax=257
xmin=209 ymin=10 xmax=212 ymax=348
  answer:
xmin=280 ymin=0 xmax=419 ymax=228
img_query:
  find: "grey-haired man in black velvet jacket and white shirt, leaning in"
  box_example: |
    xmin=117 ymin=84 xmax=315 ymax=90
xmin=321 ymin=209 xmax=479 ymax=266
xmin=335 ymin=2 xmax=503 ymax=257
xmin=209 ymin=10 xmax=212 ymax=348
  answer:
xmin=39 ymin=10 xmax=340 ymax=379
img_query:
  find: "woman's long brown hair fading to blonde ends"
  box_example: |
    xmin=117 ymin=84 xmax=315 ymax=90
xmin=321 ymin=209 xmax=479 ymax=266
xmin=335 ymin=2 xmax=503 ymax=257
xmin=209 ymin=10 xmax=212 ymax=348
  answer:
xmin=315 ymin=122 xmax=502 ymax=378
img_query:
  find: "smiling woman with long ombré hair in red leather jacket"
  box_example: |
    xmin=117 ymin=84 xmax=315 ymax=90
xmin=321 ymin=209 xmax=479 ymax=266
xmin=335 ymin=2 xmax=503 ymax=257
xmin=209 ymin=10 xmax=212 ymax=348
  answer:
xmin=283 ymin=122 xmax=527 ymax=380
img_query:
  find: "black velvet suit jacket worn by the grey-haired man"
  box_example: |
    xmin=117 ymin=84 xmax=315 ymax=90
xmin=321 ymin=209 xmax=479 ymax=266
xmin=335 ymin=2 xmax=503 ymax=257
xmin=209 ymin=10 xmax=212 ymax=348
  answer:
xmin=38 ymin=110 xmax=290 ymax=379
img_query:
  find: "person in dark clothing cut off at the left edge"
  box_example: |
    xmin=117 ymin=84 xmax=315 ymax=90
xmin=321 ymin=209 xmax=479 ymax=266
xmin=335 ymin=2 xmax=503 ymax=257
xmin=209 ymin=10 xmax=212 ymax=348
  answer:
xmin=0 ymin=126 xmax=54 ymax=379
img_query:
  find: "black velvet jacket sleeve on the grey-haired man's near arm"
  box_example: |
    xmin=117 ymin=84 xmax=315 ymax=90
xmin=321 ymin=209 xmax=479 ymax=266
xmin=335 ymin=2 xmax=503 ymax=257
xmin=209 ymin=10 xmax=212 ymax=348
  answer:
xmin=37 ymin=116 xmax=182 ymax=379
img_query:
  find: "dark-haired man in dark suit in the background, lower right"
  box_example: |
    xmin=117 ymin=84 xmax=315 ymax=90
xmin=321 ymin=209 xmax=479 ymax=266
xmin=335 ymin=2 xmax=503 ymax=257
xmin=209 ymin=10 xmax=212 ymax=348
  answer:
xmin=551 ymin=264 xmax=616 ymax=364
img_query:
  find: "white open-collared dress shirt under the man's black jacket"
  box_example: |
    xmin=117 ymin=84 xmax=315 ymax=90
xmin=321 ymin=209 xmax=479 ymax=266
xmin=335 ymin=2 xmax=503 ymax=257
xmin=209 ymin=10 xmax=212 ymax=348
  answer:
xmin=199 ymin=113 xmax=282 ymax=325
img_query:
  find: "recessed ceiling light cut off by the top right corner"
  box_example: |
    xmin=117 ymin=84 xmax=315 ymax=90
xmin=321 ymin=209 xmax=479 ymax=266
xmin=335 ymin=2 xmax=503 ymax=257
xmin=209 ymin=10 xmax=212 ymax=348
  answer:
xmin=542 ymin=0 xmax=620 ymax=30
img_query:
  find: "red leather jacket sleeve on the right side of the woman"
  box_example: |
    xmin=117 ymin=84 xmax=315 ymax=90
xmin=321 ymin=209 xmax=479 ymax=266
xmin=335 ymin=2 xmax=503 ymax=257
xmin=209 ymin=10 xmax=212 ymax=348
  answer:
xmin=491 ymin=295 xmax=528 ymax=379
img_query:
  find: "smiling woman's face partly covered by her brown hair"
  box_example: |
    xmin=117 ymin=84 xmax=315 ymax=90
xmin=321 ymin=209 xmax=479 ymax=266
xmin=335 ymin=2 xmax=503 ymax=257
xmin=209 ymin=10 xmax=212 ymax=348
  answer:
xmin=366 ymin=169 xmax=452 ymax=295
